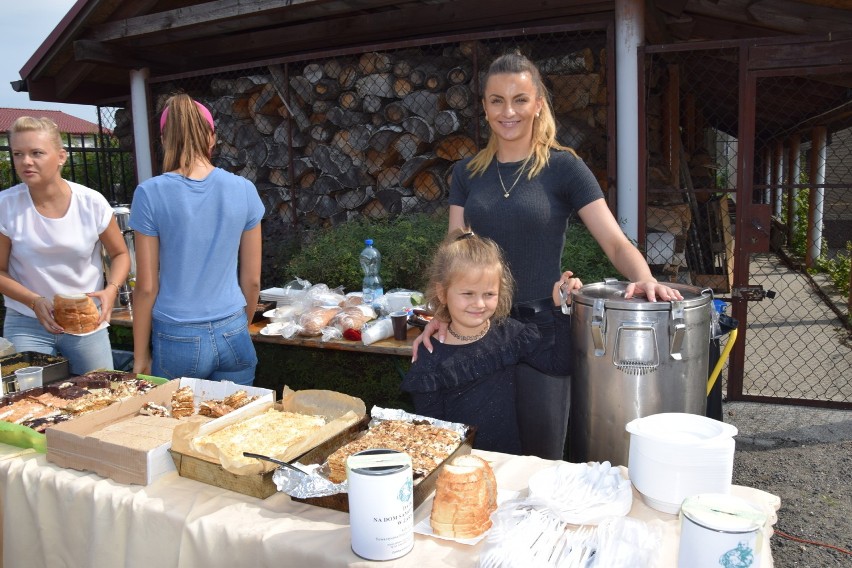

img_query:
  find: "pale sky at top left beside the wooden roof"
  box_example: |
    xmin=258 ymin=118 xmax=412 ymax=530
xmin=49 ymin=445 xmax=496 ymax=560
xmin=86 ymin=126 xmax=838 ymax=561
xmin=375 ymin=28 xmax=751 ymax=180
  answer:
xmin=0 ymin=0 xmax=97 ymax=122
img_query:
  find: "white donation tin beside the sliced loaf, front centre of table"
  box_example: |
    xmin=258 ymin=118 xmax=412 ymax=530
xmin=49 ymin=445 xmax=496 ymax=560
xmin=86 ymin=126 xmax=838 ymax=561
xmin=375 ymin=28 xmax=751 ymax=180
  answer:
xmin=346 ymin=449 xmax=414 ymax=560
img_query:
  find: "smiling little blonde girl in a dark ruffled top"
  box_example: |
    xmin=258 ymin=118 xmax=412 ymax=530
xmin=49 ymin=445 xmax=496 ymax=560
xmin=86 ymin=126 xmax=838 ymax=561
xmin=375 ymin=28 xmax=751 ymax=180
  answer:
xmin=402 ymin=230 xmax=582 ymax=454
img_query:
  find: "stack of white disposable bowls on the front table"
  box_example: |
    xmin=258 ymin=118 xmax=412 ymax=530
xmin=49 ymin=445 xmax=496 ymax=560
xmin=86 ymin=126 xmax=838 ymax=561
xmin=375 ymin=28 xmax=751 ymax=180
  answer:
xmin=626 ymin=412 xmax=737 ymax=514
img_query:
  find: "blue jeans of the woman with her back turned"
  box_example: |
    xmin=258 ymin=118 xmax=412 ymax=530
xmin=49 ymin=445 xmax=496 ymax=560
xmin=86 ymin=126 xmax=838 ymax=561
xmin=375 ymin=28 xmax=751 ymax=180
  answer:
xmin=151 ymin=310 xmax=257 ymax=386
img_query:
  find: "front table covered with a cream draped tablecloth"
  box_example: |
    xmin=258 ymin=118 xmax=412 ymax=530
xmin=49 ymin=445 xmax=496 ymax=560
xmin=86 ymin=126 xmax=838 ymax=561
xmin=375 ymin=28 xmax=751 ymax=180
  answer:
xmin=0 ymin=444 xmax=780 ymax=568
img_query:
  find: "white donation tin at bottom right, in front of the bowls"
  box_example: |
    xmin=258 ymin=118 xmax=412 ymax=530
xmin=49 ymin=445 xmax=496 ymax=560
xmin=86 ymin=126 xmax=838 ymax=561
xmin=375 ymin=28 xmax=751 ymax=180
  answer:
xmin=678 ymin=493 xmax=767 ymax=568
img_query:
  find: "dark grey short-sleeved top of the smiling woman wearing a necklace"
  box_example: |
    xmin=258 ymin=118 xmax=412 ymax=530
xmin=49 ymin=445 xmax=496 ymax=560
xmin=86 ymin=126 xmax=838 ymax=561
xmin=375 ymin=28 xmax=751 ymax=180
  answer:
xmin=449 ymin=150 xmax=604 ymax=302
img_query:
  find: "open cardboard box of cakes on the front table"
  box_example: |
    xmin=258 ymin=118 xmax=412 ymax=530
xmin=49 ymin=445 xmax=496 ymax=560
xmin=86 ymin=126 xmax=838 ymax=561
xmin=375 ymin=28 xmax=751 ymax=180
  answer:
xmin=45 ymin=378 xmax=275 ymax=485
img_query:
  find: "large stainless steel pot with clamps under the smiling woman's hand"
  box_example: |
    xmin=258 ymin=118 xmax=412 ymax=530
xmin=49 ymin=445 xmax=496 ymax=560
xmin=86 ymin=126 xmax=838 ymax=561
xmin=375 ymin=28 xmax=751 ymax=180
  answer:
xmin=568 ymin=279 xmax=713 ymax=466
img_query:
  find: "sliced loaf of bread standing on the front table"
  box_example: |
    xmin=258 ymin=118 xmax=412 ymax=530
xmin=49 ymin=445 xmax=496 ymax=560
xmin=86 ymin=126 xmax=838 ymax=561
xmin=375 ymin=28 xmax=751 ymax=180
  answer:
xmin=429 ymin=455 xmax=497 ymax=538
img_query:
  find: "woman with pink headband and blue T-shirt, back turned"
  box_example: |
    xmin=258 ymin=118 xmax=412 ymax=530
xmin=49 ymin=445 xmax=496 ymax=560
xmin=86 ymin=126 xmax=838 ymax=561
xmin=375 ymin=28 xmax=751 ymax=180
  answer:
xmin=130 ymin=94 xmax=264 ymax=385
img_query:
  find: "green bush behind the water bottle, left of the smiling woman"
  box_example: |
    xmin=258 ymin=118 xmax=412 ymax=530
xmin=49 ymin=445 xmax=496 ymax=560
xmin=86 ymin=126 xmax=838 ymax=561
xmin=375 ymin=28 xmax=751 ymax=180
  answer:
xmin=287 ymin=214 xmax=447 ymax=292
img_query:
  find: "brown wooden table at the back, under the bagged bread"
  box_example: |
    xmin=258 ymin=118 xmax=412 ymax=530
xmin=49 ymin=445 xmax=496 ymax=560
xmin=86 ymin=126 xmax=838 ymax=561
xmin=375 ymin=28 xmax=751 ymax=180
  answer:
xmin=110 ymin=308 xmax=420 ymax=358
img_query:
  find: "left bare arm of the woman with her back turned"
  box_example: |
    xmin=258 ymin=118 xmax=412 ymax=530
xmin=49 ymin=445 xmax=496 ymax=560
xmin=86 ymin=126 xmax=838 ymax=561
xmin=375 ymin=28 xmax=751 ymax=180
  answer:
xmin=133 ymin=231 xmax=160 ymax=375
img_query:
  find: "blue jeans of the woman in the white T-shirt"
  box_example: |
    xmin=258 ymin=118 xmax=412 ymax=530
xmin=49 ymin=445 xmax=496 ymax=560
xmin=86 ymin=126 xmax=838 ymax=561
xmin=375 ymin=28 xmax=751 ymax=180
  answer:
xmin=3 ymin=310 xmax=113 ymax=375
